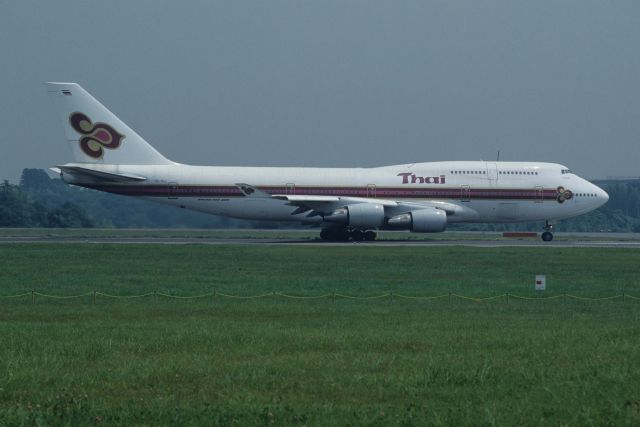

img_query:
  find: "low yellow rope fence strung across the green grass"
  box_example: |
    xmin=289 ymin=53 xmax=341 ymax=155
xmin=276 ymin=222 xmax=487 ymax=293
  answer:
xmin=0 ymin=291 xmax=640 ymax=304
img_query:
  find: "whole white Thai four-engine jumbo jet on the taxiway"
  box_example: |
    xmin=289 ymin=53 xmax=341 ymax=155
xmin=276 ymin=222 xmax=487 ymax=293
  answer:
xmin=45 ymin=82 xmax=609 ymax=242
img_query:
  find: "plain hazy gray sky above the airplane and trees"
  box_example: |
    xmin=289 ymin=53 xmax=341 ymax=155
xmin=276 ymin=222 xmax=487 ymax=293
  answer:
xmin=0 ymin=0 xmax=640 ymax=182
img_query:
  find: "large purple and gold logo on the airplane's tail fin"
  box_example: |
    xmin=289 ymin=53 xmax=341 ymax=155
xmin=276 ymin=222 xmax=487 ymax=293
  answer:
xmin=69 ymin=112 xmax=125 ymax=159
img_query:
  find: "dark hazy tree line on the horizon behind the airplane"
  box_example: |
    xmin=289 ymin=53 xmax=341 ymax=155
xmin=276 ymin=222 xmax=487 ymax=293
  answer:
xmin=0 ymin=169 xmax=640 ymax=232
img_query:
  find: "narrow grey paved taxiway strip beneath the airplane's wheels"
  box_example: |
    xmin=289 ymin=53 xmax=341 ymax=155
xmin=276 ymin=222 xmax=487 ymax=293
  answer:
xmin=0 ymin=237 xmax=640 ymax=249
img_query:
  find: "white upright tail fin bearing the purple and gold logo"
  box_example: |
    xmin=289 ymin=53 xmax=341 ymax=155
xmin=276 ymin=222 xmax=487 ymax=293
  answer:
xmin=45 ymin=83 xmax=173 ymax=165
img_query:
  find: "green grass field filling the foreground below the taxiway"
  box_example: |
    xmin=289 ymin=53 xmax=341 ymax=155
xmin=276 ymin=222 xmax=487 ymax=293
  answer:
xmin=0 ymin=244 xmax=640 ymax=426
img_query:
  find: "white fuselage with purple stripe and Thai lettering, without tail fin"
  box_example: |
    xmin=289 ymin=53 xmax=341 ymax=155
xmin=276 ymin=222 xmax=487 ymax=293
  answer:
xmin=63 ymin=161 xmax=608 ymax=227
